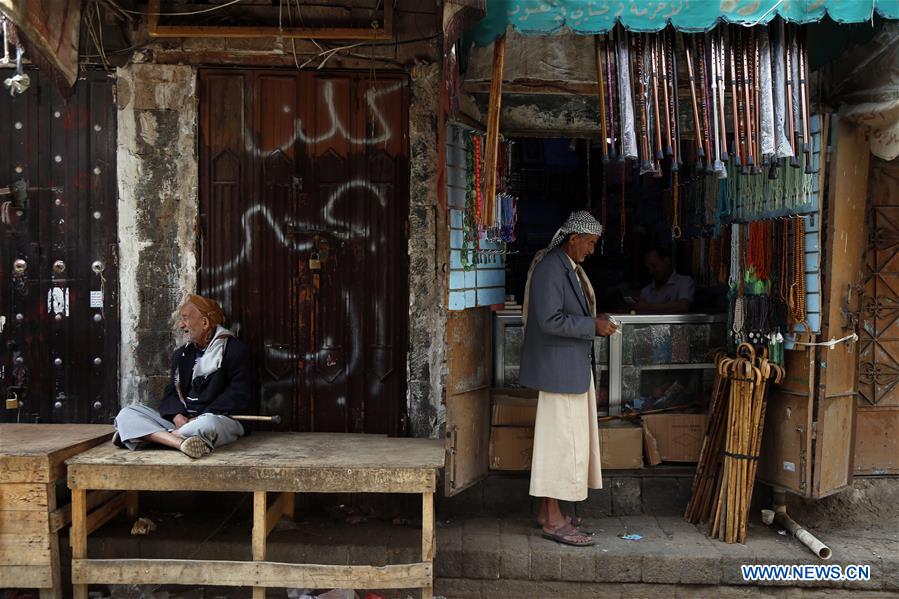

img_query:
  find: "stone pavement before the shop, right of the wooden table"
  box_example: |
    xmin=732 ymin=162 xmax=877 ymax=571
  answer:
xmin=436 ymin=515 xmax=899 ymax=598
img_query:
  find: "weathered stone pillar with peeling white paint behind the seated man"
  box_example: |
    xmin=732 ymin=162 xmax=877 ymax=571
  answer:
xmin=116 ymin=64 xmax=199 ymax=406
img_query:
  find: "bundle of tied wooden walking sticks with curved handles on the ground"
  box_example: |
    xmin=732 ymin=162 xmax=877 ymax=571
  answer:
xmin=684 ymin=343 xmax=784 ymax=543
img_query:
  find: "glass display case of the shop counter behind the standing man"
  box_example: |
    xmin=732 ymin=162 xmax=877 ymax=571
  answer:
xmin=493 ymin=314 xmax=727 ymax=415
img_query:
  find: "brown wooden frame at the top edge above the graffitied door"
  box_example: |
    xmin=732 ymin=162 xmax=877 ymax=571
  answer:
xmin=147 ymin=0 xmax=393 ymax=40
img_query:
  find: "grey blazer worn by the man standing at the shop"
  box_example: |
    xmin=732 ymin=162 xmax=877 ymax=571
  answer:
xmin=518 ymin=248 xmax=596 ymax=393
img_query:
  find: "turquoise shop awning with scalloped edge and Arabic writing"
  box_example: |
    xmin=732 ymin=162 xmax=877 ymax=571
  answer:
xmin=468 ymin=0 xmax=899 ymax=46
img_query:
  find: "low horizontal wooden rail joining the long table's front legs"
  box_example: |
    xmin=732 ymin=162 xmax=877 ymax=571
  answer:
xmin=72 ymin=558 xmax=433 ymax=589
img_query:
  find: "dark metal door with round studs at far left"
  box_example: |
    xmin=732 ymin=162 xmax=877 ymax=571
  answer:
xmin=0 ymin=70 xmax=119 ymax=422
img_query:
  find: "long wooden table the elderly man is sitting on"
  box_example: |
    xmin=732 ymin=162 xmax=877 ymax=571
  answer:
xmin=68 ymin=433 xmax=444 ymax=599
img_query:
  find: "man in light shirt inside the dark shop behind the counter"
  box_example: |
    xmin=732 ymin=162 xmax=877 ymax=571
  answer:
xmin=626 ymin=246 xmax=696 ymax=314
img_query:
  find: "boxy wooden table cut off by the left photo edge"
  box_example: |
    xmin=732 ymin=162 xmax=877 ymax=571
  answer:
xmin=0 ymin=424 xmax=113 ymax=597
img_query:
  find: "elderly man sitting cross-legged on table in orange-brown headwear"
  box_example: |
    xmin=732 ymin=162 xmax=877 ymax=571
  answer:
xmin=113 ymin=295 xmax=252 ymax=458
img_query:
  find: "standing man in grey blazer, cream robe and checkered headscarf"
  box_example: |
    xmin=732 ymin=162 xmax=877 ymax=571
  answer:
xmin=519 ymin=211 xmax=615 ymax=546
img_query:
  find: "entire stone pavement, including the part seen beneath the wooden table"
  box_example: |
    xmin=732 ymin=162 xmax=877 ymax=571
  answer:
xmin=33 ymin=504 xmax=899 ymax=599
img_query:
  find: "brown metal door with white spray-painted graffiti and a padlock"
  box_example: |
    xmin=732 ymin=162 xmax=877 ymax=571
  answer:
xmin=200 ymin=69 xmax=409 ymax=433
